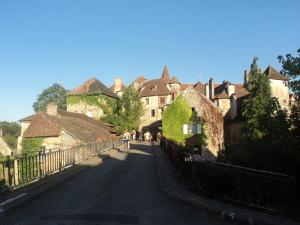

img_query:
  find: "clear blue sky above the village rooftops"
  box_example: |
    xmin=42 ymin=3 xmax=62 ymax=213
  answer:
xmin=0 ymin=0 xmax=300 ymax=121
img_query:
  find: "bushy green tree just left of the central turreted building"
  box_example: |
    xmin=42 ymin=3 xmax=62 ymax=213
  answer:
xmin=104 ymin=87 xmax=143 ymax=133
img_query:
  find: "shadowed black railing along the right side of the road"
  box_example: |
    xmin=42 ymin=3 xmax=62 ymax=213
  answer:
xmin=160 ymin=139 xmax=296 ymax=211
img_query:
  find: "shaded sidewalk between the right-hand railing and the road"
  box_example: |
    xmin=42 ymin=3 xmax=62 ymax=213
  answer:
xmin=154 ymin=144 xmax=299 ymax=225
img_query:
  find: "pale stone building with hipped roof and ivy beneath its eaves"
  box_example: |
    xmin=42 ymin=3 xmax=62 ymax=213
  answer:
xmin=67 ymin=78 xmax=122 ymax=119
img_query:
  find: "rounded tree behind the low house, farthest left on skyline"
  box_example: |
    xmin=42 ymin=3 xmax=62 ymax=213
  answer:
xmin=33 ymin=83 xmax=67 ymax=112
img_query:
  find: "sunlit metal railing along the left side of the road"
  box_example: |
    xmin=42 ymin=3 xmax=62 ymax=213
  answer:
xmin=0 ymin=139 xmax=123 ymax=194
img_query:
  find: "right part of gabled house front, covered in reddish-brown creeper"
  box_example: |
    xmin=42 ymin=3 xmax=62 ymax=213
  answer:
xmin=182 ymin=87 xmax=224 ymax=160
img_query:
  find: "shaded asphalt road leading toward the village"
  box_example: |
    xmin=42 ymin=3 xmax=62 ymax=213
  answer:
xmin=1 ymin=143 xmax=227 ymax=225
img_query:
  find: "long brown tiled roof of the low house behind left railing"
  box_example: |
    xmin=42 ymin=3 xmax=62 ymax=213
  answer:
xmin=23 ymin=111 xmax=115 ymax=142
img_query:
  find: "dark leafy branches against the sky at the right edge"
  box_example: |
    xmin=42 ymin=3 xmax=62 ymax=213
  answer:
xmin=278 ymin=48 xmax=300 ymax=97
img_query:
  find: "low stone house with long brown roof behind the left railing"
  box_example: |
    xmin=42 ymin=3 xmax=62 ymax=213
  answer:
xmin=18 ymin=103 xmax=116 ymax=153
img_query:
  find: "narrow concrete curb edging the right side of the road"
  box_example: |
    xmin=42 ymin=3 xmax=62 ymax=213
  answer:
xmin=153 ymin=146 xmax=298 ymax=225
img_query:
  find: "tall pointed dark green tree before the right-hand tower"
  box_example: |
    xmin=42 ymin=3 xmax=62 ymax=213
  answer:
xmin=242 ymin=57 xmax=289 ymax=141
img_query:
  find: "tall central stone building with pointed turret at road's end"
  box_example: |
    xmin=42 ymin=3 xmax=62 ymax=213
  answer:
xmin=131 ymin=66 xmax=181 ymax=128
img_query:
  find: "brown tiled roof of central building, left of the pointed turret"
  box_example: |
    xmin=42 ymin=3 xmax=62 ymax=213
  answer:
xmin=140 ymin=79 xmax=171 ymax=97
